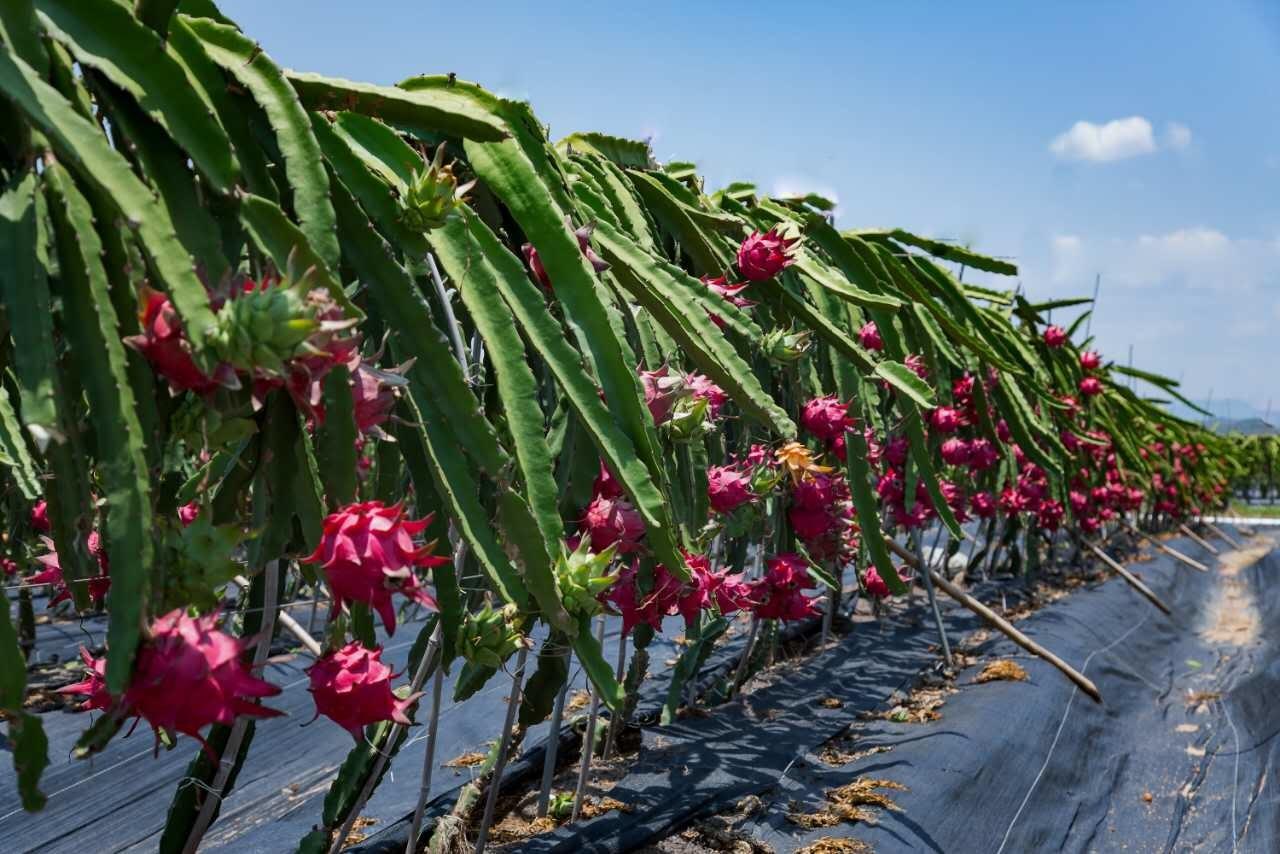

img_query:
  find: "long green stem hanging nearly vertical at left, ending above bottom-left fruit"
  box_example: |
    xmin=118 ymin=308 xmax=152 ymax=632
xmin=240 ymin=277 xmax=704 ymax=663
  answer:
xmin=44 ymin=163 xmax=152 ymax=694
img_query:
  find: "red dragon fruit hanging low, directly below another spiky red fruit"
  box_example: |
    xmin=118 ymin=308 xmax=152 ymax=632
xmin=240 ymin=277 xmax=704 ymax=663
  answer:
xmin=306 ymin=641 xmax=421 ymax=741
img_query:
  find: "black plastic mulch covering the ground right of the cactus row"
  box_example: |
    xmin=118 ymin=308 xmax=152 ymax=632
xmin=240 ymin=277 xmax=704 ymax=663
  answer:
xmin=494 ymin=530 xmax=1280 ymax=854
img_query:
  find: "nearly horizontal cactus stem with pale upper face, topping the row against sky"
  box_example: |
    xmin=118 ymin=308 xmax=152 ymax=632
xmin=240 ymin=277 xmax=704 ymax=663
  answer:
xmin=284 ymin=70 xmax=507 ymax=142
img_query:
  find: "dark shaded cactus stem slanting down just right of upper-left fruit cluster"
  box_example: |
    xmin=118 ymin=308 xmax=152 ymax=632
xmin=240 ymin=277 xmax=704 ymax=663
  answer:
xmin=322 ymin=179 xmax=511 ymax=478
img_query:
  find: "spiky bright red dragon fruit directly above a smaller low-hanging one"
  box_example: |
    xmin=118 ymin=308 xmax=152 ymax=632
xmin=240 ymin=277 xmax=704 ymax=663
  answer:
xmin=302 ymin=501 xmax=448 ymax=635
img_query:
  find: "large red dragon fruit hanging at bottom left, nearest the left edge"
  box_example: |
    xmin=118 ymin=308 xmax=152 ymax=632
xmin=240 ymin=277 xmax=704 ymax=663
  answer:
xmin=64 ymin=609 xmax=283 ymax=749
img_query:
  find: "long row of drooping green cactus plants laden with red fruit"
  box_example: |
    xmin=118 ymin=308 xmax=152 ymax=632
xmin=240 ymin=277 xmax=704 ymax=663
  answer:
xmin=0 ymin=0 xmax=1234 ymax=851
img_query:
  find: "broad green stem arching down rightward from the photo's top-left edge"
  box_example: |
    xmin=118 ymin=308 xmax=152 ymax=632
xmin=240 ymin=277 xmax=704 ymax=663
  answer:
xmin=35 ymin=0 xmax=239 ymax=193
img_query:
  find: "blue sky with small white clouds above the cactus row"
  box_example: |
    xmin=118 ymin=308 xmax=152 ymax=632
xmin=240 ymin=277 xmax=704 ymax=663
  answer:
xmin=220 ymin=0 xmax=1280 ymax=415
